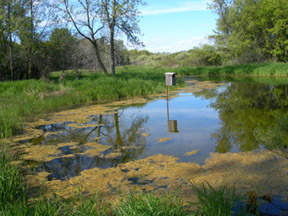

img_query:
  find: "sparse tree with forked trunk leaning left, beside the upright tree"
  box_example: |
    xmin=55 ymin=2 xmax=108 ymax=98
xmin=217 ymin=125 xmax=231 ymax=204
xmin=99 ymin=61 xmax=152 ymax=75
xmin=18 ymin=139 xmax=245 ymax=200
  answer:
xmin=60 ymin=0 xmax=108 ymax=74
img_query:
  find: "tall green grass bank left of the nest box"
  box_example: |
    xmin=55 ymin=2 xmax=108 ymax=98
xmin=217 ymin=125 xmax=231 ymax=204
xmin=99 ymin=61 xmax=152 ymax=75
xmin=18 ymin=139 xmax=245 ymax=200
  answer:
xmin=0 ymin=73 xmax=183 ymax=137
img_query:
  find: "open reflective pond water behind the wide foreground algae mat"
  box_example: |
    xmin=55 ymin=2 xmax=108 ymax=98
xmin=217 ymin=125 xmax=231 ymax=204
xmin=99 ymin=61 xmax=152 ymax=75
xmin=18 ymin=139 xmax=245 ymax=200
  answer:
xmin=15 ymin=78 xmax=288 ymax=180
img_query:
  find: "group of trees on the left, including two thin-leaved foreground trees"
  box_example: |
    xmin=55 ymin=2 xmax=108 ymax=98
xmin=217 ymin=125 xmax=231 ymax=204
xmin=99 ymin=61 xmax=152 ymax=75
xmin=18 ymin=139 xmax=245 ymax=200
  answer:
xmin=0 ymin=0 xmax=143 ymax=80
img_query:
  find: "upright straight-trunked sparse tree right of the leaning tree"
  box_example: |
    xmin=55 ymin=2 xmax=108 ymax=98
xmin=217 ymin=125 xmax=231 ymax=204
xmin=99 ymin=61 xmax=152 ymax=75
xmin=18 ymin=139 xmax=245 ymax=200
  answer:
xmin=101 ymin=0 xmax=144 ymax=75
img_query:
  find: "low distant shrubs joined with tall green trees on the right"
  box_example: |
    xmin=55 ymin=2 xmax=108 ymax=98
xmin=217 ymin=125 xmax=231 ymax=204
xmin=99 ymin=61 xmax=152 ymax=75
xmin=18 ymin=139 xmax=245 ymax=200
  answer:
xmin=130 ymin=0 xmax=288 ymax=67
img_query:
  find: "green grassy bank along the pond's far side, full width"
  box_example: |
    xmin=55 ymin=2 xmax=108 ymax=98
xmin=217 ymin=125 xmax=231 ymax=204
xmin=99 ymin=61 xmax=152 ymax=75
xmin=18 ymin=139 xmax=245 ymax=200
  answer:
xmin=0 ymin=63 xmax=288 ymax=137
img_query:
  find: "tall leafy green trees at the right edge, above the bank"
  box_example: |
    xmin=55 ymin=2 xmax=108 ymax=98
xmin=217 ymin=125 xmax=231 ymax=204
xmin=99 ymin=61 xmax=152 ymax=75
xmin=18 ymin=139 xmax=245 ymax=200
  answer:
xmin=210 ymin=0 xmax=288 ymax=63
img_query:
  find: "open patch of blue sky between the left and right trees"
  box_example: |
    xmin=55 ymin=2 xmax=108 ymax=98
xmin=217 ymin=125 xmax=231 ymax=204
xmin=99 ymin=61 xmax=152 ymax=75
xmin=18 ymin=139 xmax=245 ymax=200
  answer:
xmin=131 ymin=0 xmax=217 ymax=52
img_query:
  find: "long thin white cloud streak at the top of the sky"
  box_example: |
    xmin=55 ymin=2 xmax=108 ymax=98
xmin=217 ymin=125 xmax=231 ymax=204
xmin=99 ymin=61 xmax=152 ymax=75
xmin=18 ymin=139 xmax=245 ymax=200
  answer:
xmin=142 ymin=0 xmax=210 ymax=16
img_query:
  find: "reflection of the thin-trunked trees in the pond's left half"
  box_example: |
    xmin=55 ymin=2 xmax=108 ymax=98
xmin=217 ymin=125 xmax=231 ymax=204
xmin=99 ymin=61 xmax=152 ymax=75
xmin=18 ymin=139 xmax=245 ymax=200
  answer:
xmin=36 ymin=112 xmax=148 ymax=179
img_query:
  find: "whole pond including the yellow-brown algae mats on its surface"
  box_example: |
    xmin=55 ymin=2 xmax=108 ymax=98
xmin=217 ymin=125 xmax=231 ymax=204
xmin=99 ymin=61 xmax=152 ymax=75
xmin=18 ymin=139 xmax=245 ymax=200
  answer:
xmin=13 ymin=78 xmax=288 ymax=215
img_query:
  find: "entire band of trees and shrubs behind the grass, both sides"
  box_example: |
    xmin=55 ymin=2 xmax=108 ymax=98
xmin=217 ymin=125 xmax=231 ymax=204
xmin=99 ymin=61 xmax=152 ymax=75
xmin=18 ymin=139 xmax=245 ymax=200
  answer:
xmin=0 ymin=0 xmax=288 ymax=80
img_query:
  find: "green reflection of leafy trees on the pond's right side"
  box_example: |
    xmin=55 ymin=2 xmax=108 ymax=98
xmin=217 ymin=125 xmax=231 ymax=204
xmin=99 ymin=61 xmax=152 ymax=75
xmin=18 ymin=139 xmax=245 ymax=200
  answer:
xmin=195 ymin=82 xmax=288 ymax=153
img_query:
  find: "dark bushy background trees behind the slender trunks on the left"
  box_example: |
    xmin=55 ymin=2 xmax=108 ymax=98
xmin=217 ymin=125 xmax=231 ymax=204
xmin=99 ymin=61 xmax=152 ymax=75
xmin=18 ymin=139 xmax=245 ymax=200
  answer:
xmin=0 ymin=28 xmax=129 ymax=80
